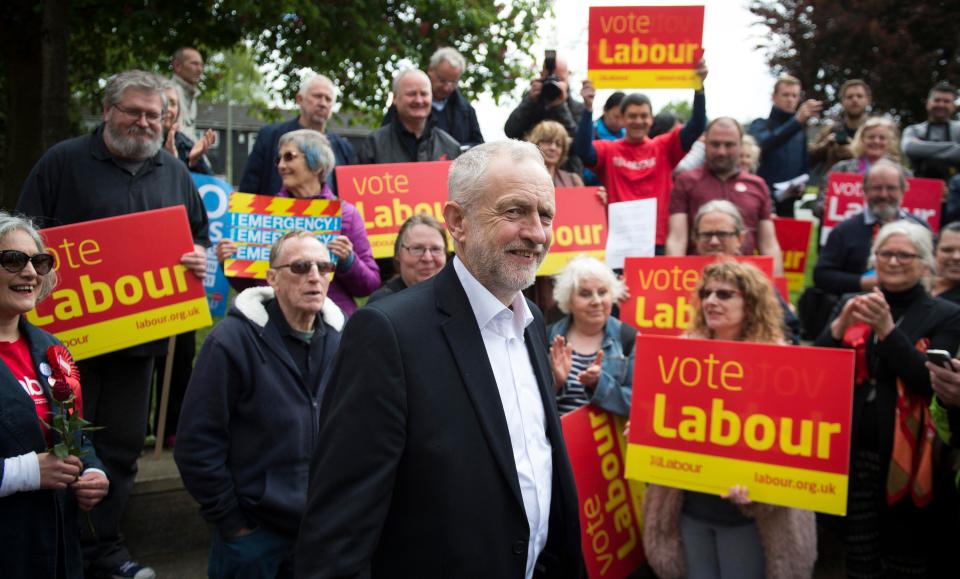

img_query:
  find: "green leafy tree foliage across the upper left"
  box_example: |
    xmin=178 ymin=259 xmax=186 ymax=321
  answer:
xmin=0 ymin=0 xmax=549 ymax=207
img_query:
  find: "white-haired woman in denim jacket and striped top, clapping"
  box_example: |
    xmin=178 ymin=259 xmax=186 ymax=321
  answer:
xmin=547 ymin=255 xmax=637 ymax=416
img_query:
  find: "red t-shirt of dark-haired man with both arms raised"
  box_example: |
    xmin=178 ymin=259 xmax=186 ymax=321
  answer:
xmin=593 ymin=127 xmax=686 ymax=245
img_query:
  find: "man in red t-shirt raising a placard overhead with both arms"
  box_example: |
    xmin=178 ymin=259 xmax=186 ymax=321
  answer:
xmin=574 ymin=60 xmax=707 ymax=255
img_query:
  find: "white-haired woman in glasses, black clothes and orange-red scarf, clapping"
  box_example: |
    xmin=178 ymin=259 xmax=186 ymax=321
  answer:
xmin=816 ymin=221 xmax=960 ymax=577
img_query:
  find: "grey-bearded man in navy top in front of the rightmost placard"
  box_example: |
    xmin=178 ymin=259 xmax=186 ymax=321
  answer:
xmin=813 ymin=159 xmax=927 ymax=297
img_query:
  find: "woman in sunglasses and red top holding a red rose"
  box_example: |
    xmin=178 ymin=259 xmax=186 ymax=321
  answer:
xmin=0 ymin=212 xmax=110 ymax=579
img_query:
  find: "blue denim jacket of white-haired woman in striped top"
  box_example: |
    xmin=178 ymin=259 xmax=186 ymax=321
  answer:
xmin=547 ymin=314 xmax=635 ymax=416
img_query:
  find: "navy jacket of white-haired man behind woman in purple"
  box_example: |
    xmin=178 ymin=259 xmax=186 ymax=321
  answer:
xmin=237 ymin=117 xmax=357 ymax=195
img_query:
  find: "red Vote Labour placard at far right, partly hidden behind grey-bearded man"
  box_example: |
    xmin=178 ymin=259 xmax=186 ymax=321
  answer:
xmin=820 ymin=173 xmax=943 ymax=245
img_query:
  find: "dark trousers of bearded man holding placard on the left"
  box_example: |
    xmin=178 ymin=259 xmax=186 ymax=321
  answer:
xmin=77 ymin=351 xmax=153 ymax=570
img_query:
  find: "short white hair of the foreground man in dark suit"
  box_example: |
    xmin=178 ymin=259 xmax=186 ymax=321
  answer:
xmin=447 ymin=139 xmax=547 ymax=213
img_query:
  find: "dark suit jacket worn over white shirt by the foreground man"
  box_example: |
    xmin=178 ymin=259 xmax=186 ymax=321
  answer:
xmin=296 ymin=263 xmax=581 ymax=579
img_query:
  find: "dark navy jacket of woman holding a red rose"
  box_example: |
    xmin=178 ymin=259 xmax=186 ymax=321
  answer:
xmin=0 ymin=316 xmax=104 ymax=579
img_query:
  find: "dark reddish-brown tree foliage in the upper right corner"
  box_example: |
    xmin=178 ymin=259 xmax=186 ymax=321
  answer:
xmin=750 ymin=0 xmax=960 ymax=125
